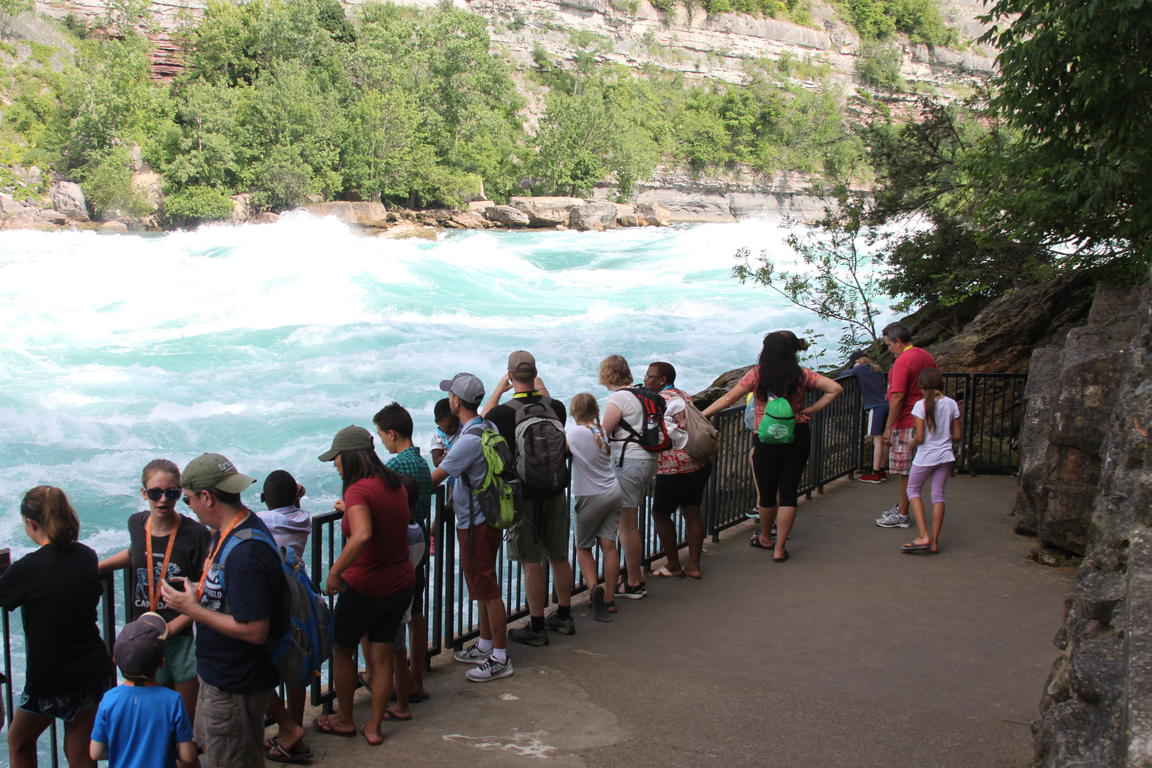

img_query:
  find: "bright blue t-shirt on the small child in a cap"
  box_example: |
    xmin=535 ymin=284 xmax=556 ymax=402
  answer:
xmin=92 ymin=685 xmax=192 ymax=768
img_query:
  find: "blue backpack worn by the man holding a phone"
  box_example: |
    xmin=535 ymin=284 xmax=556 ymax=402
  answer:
xmin=219 ymin=529 xmax=332 ymax=686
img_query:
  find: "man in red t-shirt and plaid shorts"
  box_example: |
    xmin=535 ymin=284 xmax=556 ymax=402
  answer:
xmin=876 ymin=322 xmax=937 ymax=529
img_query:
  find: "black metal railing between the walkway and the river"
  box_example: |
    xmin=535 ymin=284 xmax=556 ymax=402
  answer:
xmin=0 ymin=373 xmax=1026 ymax=750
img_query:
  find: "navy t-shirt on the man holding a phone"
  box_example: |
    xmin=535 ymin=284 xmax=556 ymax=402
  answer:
xmin=190 ymin=514 xmax=286 ymax=693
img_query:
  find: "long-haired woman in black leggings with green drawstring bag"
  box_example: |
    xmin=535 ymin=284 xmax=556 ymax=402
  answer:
xmin=704 ymin=330 xmax=844 ymax=563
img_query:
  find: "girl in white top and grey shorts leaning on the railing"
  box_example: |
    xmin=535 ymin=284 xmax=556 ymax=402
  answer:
xmin=567 ymin=391 xmax=622 ymax=622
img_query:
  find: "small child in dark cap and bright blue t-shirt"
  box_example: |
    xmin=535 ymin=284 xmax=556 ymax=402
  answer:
xmin=89 ymin=611 xmax=199 ymax=768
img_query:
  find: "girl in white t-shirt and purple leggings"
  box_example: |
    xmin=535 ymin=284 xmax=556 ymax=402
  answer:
xmin=901 ymin=368 xmax=960 ymax=555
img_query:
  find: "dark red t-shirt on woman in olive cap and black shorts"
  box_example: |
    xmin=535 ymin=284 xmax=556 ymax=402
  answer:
xmin=340 ymin=477 xmax=416 ymax=598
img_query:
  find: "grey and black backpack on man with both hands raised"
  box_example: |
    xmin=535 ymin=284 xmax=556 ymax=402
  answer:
xmin=508 ymin=396 xmax=568 ymax=496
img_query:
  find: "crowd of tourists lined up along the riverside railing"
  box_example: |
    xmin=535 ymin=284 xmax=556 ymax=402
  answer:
xmin=0 ymin=324 xmax=958 ymax=768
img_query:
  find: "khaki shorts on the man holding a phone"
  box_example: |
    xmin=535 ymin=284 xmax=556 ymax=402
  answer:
xmin=192 ymin=680 xmax=272 ymax=768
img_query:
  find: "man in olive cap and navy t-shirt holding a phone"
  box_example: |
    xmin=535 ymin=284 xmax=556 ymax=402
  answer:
xmin=162 ymin=454 xmax=287 ymax=768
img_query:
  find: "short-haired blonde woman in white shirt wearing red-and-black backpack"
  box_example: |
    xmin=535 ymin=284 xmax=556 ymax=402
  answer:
xmin=600 ymin=355 xmax=657 ymax=600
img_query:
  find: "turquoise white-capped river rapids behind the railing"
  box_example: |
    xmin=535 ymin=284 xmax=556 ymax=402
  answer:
xmin=0 ymin=214 xmax=835 ymax=556
